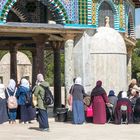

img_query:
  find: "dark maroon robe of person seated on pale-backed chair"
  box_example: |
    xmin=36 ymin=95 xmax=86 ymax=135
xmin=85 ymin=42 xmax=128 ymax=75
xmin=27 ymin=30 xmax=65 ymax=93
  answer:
xmin=115 ymin=98 xmax=133 ymax=124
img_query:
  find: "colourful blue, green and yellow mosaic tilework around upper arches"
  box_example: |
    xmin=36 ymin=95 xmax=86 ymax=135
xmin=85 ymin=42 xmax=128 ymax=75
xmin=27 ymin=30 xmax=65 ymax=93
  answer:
xmin=0 ymin=0 xmax=135 ymax=32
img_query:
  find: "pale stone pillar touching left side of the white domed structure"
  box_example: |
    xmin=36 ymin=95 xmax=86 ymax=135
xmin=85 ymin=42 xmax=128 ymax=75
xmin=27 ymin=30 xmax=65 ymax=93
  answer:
xmin=64 ymin=35 xmax=74 ymax=98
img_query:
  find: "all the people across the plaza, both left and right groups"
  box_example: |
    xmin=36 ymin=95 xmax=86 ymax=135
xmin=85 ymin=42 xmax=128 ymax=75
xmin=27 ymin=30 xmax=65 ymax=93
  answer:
xmin=0 ymin=74 xmax=140 ymax=131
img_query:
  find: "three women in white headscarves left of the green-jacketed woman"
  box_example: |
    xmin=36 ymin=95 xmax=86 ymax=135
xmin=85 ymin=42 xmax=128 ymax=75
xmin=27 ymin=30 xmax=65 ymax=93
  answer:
xmin=0 ymin=78 xmax=35 ymax=124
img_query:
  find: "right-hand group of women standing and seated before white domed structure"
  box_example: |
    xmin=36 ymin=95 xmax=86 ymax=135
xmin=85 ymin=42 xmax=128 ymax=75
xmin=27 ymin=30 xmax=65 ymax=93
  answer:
xmin=69 ymin=77 xmax=140 ymax=124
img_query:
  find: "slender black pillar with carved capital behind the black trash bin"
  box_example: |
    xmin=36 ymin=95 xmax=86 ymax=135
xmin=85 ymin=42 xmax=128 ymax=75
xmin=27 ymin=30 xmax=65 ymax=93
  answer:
xmin=51 ymin=41 xmax=63 ymax=112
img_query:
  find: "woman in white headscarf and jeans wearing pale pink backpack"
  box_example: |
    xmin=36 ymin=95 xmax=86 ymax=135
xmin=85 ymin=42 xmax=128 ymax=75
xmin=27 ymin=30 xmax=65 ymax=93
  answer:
xmin=5 ymin=79 xmax=17 ymax=124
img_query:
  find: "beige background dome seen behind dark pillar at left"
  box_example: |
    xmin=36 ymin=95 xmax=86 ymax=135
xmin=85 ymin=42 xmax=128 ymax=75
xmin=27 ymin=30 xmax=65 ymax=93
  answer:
xmin=1 ymin=52 xmax=31 ymax=65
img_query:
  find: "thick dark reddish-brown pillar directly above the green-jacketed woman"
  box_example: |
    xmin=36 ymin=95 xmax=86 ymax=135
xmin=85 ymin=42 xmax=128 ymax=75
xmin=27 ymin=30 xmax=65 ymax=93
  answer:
xmin=33 ymin=35 xmax=47 ymax=75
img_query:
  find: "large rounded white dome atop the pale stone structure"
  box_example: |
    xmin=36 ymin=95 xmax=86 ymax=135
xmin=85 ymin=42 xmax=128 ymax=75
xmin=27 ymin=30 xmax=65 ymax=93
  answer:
xmin=91 ymin=27 xmax=126 ymax=54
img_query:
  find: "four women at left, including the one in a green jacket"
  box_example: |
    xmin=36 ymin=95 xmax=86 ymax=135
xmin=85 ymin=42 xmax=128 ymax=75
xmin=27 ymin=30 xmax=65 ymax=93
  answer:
xmin=0 ymin=74 xmax=49 ymax=131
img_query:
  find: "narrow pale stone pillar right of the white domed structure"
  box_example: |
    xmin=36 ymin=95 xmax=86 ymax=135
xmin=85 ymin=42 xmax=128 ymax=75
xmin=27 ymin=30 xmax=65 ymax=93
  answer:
xmin=127 ymin=46 xmax=133 ymax=84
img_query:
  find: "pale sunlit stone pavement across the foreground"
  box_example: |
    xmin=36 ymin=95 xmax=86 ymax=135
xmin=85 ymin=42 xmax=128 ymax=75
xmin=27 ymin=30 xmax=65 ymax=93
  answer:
xmin=0 ymin=118 xmax=140 ymax=140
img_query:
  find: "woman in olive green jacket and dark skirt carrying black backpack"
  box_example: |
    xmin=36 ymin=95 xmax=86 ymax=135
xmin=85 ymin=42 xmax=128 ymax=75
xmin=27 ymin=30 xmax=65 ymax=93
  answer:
xmin=33 ymin=73 xmax=49 ymax=131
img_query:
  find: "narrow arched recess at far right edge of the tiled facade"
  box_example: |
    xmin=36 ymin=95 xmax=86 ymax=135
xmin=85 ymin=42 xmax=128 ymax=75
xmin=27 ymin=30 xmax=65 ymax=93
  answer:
xmin=128 ymin=12 xmax=135 ymax=38
